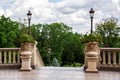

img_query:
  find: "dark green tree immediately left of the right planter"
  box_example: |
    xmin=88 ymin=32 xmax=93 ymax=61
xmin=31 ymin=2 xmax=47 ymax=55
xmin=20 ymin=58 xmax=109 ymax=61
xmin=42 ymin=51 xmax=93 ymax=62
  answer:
xmin=62 ymin=32 xmax=84 ymax=65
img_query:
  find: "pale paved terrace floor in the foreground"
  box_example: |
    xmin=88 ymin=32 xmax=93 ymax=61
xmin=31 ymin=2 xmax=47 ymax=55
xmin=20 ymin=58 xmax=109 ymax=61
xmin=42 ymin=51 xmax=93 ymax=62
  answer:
xmin=0 ymin=67 xmax=120 ymax=80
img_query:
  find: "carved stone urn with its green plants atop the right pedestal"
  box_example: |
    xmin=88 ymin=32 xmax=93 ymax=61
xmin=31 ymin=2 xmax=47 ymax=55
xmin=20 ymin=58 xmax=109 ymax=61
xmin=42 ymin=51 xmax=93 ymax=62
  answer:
xmin=82 ymin=33 xmax=102 ymax=53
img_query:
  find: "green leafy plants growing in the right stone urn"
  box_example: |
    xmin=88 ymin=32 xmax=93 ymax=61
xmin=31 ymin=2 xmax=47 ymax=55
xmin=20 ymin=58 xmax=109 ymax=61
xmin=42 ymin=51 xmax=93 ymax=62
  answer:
xmin=82 ymin=33 xmax=102 ymax=43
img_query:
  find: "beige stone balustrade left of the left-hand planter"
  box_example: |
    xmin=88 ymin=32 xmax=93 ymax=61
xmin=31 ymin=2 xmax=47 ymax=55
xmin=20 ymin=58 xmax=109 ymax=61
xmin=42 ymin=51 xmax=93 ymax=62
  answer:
xmin=0 ymin=48 xmax=21 ymax=64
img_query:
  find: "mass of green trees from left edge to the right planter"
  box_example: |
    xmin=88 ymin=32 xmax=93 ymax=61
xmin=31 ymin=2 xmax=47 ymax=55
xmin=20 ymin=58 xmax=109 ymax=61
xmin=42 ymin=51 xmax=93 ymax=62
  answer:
xmin=0 ymin=16 xmax=84 ymax=65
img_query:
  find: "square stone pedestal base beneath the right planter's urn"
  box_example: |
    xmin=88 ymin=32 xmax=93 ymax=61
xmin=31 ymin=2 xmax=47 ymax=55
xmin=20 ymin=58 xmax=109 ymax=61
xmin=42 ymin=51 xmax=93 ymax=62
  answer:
xmin=85 ymin=57 xmax=98 ymax=73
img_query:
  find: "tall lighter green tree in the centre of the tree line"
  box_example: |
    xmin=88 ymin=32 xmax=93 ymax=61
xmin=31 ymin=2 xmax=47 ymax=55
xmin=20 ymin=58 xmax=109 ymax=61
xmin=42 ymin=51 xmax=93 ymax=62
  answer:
xmin=48 ymin=23 xmax=71 ymax=63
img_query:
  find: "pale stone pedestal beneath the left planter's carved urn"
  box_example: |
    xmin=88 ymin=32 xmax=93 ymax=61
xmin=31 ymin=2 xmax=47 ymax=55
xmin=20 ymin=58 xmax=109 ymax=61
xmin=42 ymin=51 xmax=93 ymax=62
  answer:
xmin=20 ymin=51 xmax=32 ymax=71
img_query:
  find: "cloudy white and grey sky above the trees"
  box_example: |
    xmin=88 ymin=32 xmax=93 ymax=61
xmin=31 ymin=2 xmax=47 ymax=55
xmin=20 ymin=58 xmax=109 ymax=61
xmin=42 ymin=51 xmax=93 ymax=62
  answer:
xmin=0 ymin=0 xmax=120 ymax=33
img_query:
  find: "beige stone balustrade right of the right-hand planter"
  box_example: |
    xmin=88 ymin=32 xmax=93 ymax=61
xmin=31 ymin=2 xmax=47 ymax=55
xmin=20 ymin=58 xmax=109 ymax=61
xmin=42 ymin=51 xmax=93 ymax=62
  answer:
xmin=99 ymin=48 xmax=120 ymax=68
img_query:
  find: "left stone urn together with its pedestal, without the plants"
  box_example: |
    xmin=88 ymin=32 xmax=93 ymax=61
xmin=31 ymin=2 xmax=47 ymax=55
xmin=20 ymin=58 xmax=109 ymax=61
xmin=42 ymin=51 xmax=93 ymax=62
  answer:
xmin=20 ymin=43 xmax=34 ymax=71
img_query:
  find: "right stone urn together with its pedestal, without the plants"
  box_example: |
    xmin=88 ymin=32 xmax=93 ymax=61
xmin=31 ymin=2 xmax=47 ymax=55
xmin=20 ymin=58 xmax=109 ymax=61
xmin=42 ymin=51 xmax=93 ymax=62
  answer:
xmin=84 ymin=42 xmax=100 ymax=72
